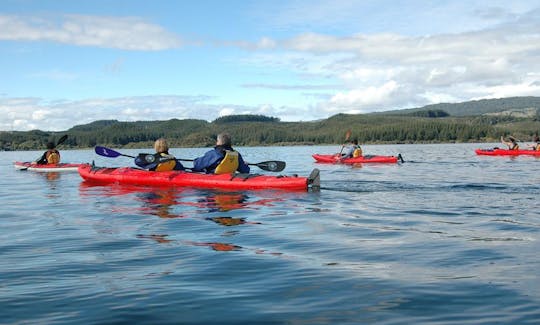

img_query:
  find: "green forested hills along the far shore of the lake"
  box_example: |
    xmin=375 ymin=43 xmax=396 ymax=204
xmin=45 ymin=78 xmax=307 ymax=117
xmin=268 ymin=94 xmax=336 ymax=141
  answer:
xmin=0 ymin=97 xmax=540 ymax=151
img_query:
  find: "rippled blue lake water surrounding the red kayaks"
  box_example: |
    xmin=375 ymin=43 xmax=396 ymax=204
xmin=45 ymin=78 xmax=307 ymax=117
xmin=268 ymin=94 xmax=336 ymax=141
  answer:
xmin=0 ymin=144 xmax=540 ymax=324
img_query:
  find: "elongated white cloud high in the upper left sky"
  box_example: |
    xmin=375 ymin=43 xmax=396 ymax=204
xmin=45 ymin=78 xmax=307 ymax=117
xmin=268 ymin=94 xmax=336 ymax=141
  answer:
xmin=0 ymin=15 xmax=182 ymax=51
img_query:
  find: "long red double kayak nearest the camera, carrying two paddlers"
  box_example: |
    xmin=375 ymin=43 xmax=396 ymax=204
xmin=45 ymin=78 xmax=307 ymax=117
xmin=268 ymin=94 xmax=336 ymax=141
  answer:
xmin=78 ymin=164 xmax=320 ymax=191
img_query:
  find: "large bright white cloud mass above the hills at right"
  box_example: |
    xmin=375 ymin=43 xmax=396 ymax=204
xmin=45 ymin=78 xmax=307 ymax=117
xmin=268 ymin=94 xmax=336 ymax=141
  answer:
xmin=238 ymin=8 xmax=540 ymax=115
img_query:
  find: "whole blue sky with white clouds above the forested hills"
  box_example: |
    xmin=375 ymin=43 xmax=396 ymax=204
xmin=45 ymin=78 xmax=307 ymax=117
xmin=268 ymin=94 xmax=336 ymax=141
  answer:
xmin=0 ymin=0 xmax=540 ymax=131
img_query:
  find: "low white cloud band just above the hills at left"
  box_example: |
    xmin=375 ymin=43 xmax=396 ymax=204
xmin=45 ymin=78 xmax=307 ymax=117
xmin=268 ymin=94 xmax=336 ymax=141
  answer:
xmin=0 ymin=96 xmax=268 ymax=131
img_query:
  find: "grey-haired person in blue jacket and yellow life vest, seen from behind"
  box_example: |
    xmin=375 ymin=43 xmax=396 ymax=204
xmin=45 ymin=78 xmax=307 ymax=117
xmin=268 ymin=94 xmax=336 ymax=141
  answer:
xmin=193 ymin=133 xmax=249 ymax=174
